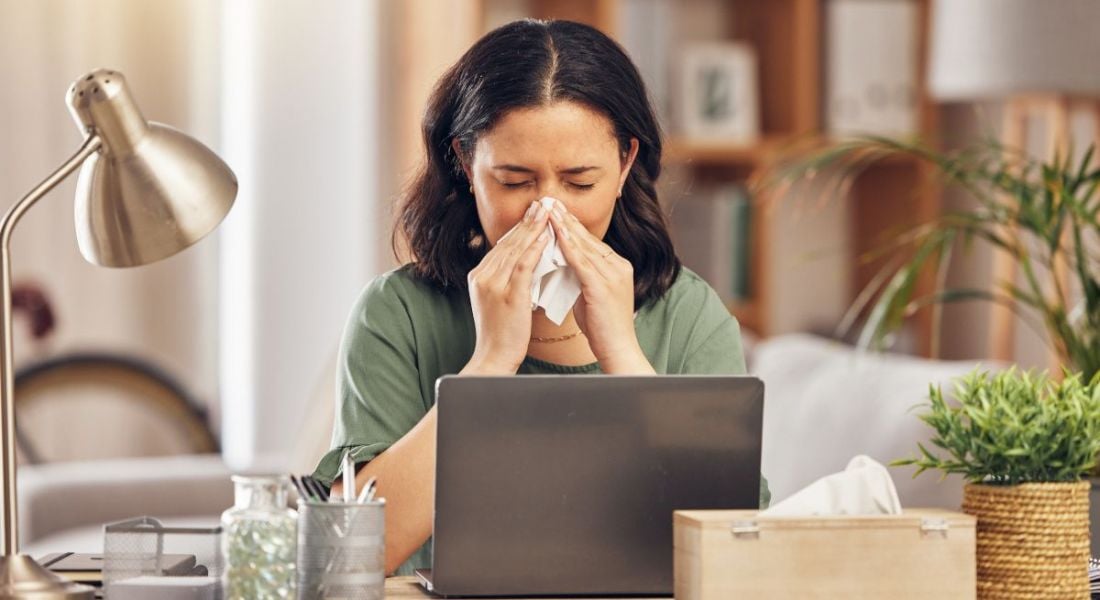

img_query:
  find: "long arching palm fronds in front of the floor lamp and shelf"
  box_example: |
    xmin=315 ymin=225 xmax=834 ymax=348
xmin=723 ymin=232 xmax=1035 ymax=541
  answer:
xmin=766 ymin=137 xmax=1100 ymax=381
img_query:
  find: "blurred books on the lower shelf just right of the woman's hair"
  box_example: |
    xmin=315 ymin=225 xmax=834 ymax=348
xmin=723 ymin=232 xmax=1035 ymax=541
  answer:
xmin=671 ymin=184 xmax=752 ymax=303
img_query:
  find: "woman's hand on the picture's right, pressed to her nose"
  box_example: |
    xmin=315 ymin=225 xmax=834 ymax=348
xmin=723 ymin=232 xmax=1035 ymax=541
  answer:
xmin=550 ymin=201 xmax=653 ymax=374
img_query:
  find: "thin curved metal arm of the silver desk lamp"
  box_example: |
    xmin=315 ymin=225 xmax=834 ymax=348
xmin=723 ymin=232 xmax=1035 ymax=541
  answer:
xmin=0 ymin=134 xmax=102 ymax=556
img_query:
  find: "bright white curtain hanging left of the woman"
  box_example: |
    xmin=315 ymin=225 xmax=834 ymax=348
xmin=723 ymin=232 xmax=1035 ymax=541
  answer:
xmin=218 ymin=0 xmax=385 ymax=470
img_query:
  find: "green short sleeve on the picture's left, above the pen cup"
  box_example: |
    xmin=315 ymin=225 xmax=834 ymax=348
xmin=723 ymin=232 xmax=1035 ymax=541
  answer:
xmin=314 ymin=274 xmax=429 ymax=484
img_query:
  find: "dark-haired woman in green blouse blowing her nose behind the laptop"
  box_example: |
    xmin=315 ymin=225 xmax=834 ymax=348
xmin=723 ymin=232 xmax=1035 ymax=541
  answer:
xmin=315 ymin=21 xmax=767 ymax=575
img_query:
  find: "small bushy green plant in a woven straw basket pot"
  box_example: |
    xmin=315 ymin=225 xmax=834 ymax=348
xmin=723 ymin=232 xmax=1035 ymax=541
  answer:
xmin=893 ymin=368 xmax=1100 ymax=599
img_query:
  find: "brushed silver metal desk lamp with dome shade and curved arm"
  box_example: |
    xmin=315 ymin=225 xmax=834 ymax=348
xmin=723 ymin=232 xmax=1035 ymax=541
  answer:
xmin=0 ymin=69 xmax=237 ymax=599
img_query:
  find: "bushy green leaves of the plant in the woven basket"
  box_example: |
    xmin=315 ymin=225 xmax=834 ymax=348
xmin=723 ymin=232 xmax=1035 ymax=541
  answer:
xmin=892 ymin=368 xmax=1100 ymax=486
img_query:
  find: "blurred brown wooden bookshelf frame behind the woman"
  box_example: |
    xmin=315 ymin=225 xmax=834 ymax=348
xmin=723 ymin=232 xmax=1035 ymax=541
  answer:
xmin=475 ymin=0 xmax=941 ymax=356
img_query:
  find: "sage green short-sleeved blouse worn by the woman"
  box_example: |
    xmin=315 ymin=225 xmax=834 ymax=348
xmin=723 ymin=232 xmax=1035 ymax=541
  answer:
xmin=314 ymin=265 xmax=770 ymax=575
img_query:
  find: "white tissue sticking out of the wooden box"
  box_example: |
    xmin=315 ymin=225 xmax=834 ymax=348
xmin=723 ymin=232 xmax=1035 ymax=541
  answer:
xmin=760 ymin=455 xmax=901 ymax=516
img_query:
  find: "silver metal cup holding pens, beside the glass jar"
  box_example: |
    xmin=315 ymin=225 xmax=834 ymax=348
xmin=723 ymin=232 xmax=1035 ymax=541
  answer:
xmin=298 ymin=499 xmax=386 ymax=600
